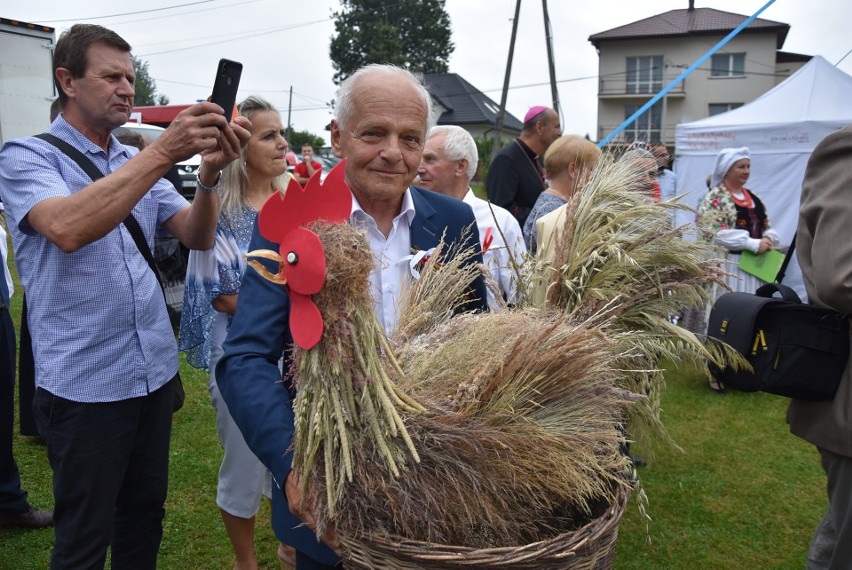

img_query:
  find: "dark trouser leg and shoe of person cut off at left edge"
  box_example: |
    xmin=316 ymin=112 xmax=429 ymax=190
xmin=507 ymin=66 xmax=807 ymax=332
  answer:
xmin=0 ymin=306 xmax=30 ymax=515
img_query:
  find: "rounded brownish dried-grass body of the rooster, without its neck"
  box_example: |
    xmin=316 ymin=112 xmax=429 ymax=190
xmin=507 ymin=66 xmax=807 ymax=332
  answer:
xmin=328 ymin=312 xmax=632 ymax=548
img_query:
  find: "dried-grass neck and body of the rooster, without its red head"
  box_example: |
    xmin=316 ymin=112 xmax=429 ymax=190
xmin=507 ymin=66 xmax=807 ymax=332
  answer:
xmin=293 ymin=220 xmax=633 ymax=548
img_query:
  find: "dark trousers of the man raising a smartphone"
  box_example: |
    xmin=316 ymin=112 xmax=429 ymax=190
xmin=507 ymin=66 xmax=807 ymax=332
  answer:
xmin=34 ymin=374 xmax=174 ymax=570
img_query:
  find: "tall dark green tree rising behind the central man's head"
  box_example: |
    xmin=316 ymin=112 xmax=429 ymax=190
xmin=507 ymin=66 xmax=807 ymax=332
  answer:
xmin=329 ymin=0 xmax=454 ymax=83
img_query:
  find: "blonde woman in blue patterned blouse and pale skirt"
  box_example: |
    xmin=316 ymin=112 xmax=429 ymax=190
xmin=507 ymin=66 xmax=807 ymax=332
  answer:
xmin=178 ymin=96 xmax=290 ymax=570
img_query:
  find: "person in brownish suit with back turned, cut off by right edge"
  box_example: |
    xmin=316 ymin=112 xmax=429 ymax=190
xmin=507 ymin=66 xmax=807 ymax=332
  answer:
xmin=787 ymin=127 xmax=852 ymax=570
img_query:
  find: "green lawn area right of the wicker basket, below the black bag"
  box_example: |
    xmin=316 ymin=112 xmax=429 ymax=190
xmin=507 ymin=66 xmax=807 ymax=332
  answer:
xmin=615 ymin=362 xmax=826 ymax=569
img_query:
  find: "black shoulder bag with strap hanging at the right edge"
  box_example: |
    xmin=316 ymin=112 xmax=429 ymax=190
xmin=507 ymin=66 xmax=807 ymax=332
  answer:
xmin=707 ymin=248 xmax=849 ymax=400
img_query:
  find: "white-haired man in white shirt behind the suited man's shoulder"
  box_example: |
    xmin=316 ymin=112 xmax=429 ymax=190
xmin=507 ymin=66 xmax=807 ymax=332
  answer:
xmin=417 ymin=125 xmax=527 ymax=309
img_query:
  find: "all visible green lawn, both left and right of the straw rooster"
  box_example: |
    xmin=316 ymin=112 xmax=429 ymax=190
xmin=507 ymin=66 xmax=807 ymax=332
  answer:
xmin=0 ymin=224 xmax=826 ymax=570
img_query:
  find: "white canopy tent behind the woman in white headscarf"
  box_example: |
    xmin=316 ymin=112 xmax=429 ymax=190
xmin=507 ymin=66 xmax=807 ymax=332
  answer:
xmin=675 ymin=56 xmax=852 ymax=294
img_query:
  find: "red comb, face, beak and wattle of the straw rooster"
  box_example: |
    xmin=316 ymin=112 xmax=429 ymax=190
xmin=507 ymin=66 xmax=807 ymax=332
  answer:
xmin=248 ymin=160 xmax=352 ymax=350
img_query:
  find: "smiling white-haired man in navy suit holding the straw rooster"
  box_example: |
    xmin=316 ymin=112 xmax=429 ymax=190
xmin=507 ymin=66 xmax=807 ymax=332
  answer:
xmin=216 ymin=65 xmax=485 ymax=570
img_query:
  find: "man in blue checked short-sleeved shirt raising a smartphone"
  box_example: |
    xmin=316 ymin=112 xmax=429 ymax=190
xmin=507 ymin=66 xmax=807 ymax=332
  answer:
xmin=0 ymin=24 xmax=251 ymax=569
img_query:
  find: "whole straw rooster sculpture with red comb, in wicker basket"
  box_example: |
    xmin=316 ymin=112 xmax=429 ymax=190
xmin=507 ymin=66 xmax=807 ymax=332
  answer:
xmin=249 ymin=155 xmax=740 ymax=568
